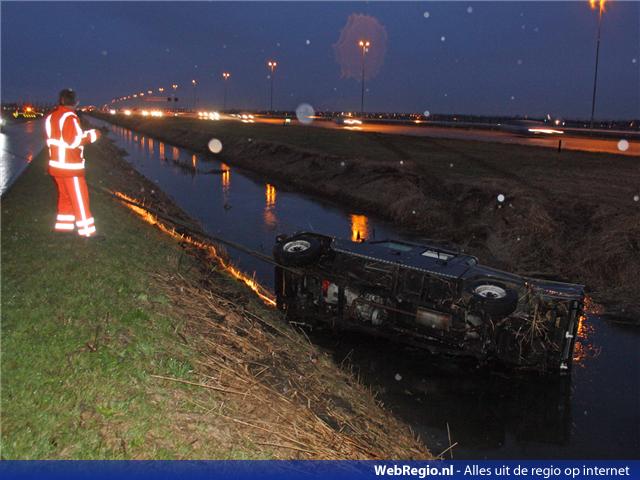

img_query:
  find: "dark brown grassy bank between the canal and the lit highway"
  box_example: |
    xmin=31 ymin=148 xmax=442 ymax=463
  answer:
xmin=90 ymin=114 xmax=640 ymax=318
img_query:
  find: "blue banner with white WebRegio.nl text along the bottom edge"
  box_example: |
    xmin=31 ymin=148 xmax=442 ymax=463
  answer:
xmin=0 ymin=460 xmax=640 ymax=480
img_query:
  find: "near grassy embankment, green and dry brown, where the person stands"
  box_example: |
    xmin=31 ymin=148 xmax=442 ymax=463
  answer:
xmin=0 ymin=133 xmax=428 ymax=459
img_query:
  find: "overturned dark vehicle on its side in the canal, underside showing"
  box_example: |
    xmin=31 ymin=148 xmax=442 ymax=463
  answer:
xmin=273 ymin=232 xmax=584 ymax=373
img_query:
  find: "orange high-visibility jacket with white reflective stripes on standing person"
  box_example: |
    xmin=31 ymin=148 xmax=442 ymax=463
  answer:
xmin=45 ymin=106 xmax=97 ymax=177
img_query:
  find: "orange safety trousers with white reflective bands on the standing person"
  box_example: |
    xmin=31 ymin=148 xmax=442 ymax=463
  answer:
xmin=53 ymin=176 xmax=96 ymax=237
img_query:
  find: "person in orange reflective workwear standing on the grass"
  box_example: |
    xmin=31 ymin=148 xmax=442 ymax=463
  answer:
xmin=45 ymin=89 xmax=100 ymax=237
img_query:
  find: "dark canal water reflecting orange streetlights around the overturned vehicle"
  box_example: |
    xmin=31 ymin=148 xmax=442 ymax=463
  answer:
xmin=40 ymin=120 xmax=640 ymax=459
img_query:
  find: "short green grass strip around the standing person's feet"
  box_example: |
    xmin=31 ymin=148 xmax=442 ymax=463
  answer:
xmin=1 ymin=148 xmax=255 ymax=459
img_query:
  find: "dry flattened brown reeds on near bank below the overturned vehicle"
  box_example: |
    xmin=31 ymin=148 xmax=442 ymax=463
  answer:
xmin=156 ymin=274 xmax=432 ymax=460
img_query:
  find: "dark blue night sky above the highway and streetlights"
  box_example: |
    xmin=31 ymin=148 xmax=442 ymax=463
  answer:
xmin=1 ymin=1 xmax=640 ymax=119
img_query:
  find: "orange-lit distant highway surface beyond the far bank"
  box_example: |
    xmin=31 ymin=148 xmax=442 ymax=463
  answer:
xmin=248 ymin=115 xmax=640 ymax=157
